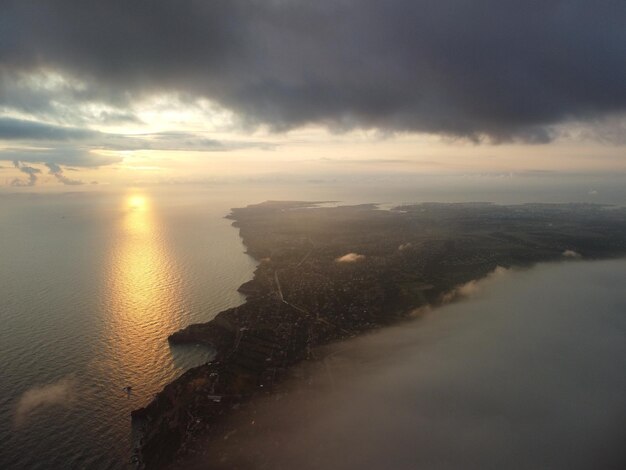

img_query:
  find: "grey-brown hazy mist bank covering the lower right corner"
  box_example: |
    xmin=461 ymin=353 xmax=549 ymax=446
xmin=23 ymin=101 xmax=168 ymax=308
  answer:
xmin=210 ymin=260 xmax=626 ymax=470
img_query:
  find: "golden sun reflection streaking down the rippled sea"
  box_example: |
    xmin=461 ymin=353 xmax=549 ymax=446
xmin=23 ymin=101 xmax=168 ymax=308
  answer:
xmin=95 ymin=194 xmax=183 ymax=399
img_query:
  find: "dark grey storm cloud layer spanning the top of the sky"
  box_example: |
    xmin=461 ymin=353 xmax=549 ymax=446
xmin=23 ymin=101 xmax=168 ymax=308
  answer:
xmin=0 ymin=0 xmax=626 ymax=142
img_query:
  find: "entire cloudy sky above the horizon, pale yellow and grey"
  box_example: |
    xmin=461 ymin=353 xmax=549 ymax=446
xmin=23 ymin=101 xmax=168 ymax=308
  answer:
xmin=0 ymin=0 xmax=626 ymax=191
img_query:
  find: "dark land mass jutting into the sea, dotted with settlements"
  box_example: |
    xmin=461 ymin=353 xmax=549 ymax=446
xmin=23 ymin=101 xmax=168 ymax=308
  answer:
xmin=132 ymin=201 xmax=626 ymax=469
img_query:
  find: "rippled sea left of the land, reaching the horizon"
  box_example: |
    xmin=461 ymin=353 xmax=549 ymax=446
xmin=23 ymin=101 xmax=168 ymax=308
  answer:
xmin=0 ymin=182 xmax=624 ymax=469
